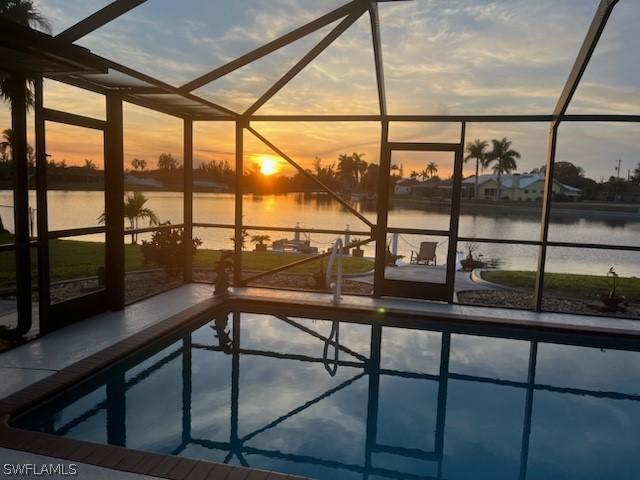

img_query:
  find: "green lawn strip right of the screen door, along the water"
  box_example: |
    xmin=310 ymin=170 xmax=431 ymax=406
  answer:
xmin=482 ymin=270 xmax=640 ymax=301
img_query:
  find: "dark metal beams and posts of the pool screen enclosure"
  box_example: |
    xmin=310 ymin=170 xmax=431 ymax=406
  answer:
xmin=3 ymin=0 xmax=640 ymax=338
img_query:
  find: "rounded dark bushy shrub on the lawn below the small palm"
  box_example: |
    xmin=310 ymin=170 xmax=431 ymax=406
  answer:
xmin=141 ymin=224 xmax=202 ymax=277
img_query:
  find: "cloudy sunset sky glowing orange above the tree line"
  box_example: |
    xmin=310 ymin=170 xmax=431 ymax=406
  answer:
xmin=0 ymin=0 xmax=640 ymax=180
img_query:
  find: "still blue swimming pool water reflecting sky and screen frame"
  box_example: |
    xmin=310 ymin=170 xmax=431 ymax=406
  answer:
xmin=15 ymin=311 xmax=640 ymax=480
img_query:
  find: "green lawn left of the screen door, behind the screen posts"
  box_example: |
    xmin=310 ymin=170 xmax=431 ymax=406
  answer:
xmin=0 ymin=239 xmax=373 ymax=288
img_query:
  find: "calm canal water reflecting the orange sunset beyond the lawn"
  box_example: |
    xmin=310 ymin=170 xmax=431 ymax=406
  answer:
xmin=0 ymin=191 xmax=640 ymax=276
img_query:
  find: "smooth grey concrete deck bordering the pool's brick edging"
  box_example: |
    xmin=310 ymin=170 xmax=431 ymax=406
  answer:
xmin=0 ymin=284 xmax=640 ymax=480
